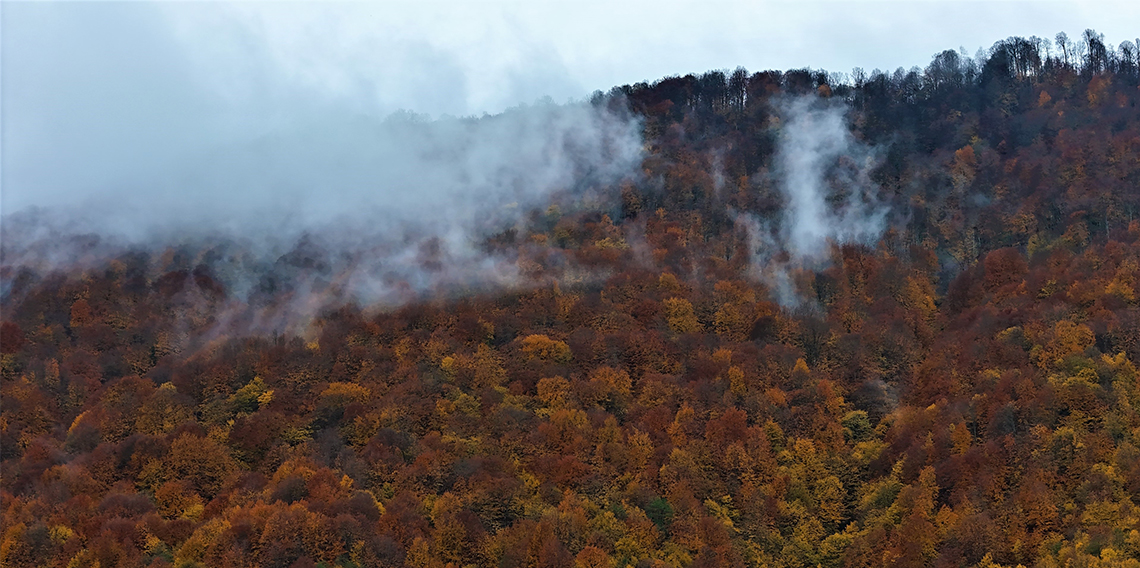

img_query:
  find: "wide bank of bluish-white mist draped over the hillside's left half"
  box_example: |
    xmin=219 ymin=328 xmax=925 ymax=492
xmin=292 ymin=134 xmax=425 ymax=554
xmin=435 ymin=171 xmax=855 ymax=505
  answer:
xmin=3 ymin=104 xmax=642 ymax=310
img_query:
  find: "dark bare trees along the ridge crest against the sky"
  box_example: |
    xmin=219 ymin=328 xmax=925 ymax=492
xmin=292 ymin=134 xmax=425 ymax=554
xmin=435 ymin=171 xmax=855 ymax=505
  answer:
xmin=594 ymin=30 xmax=1140 ymax=117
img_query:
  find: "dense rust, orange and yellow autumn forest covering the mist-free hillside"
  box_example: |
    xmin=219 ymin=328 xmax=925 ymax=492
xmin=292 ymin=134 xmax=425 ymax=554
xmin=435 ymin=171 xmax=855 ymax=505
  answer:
xmin=0 ymin=31 xmax=1140 ymax=568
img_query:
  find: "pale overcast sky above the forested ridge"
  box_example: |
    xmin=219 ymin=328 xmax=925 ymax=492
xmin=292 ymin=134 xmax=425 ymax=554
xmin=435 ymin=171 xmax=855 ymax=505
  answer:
xmin=0 ymin=0 xmax=1140 ymax=212
